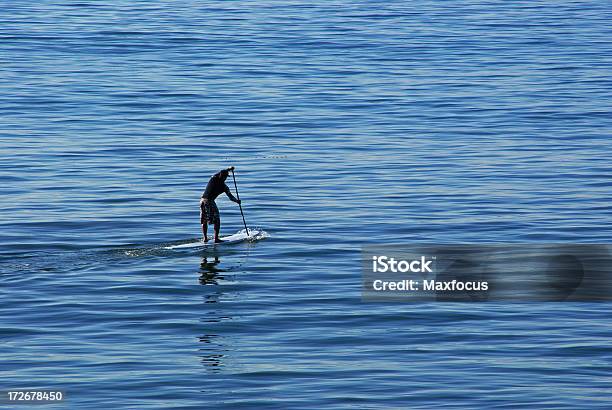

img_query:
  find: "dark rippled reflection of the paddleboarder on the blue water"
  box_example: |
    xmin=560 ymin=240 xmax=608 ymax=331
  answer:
xmin=198 ymin=255 xmax=231 ymax=372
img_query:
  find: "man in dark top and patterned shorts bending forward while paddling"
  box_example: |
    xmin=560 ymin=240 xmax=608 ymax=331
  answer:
xmin=200 ymin=167 xmax=240 ymax=243
